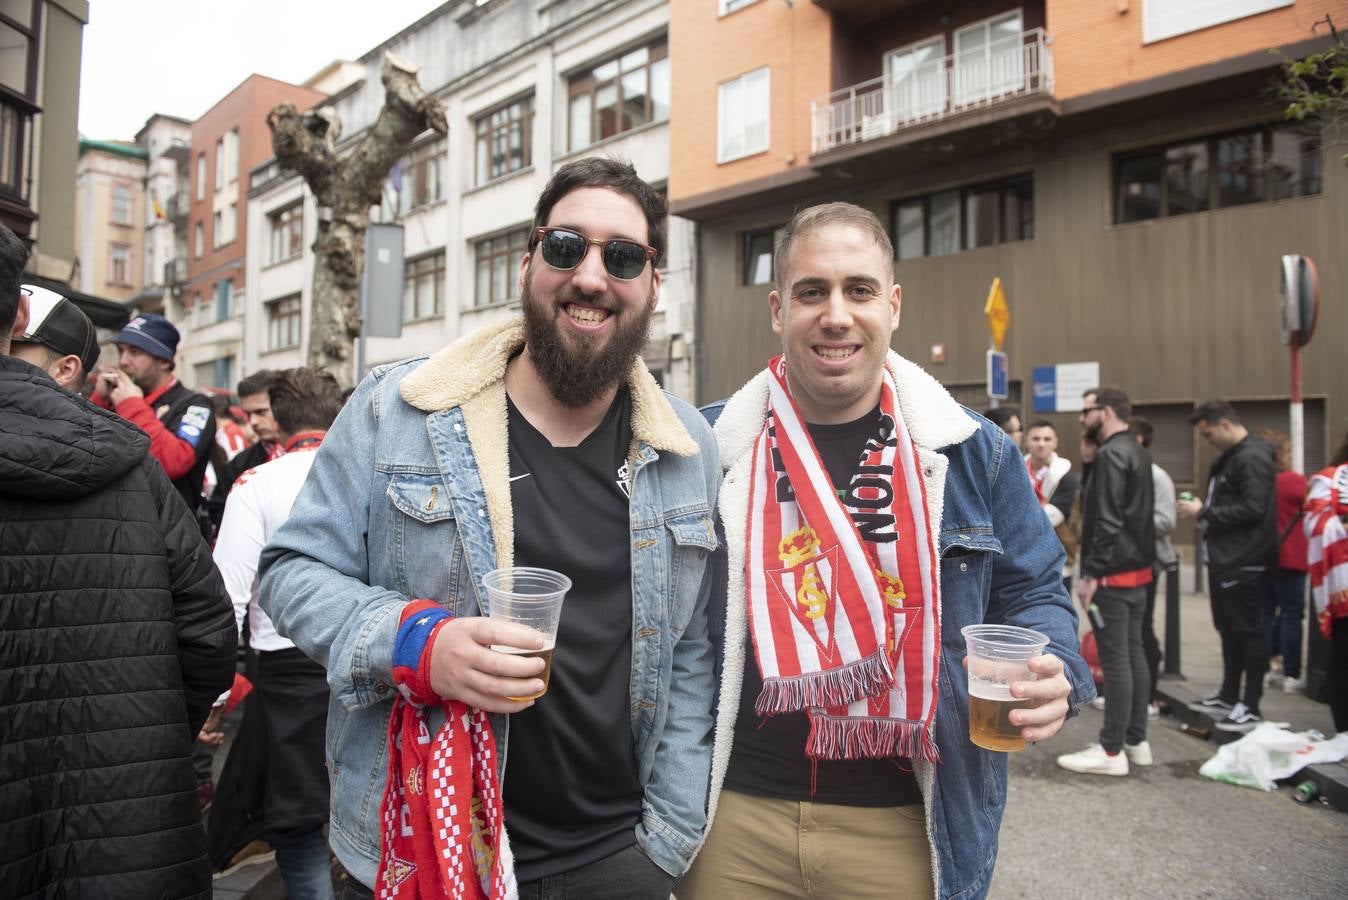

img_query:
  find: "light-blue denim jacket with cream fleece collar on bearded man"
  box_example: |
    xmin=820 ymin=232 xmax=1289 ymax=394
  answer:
xmin=260 ymin=321 xmax=720 ymax=885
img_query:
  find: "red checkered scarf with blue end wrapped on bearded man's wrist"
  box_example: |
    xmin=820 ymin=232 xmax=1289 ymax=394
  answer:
xmin=375 ymin=600 xmax=516 ymax=900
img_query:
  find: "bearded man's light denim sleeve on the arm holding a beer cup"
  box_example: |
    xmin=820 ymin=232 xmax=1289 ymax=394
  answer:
xmin=259 ymin=375 xmax=407 ymax=709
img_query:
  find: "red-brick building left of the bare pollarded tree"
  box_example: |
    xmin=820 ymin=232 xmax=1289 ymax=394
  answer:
xmin=180 ymin=74 xmax=325 ymax=388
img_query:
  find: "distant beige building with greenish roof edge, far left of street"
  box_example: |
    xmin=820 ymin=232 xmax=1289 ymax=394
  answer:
xmin=71 ymin=139 xmax=147 ymax=302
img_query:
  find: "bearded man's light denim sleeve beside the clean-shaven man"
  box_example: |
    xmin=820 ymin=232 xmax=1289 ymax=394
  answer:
xmin=638 ymin=427 xmax=720 ymax=877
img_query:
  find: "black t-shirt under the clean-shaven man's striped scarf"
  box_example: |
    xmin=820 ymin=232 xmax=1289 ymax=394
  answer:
xmin=725 ymin=407 xmax=922 ymax=807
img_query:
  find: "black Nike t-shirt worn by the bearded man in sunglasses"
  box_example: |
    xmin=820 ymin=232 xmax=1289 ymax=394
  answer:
xmin=504 ymin=388 xmax=642 ymax=881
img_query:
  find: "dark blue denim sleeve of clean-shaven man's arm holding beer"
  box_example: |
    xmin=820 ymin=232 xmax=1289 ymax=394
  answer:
xmin=985 ymin=428 xmax=1095 ymax=715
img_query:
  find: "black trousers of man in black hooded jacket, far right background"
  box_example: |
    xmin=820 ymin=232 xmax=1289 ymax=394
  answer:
xmin=1208 ymin=571 xmax=1273 ymax=713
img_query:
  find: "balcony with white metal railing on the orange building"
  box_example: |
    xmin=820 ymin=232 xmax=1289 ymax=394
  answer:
xmin=810 ymin=28 xmax=1053 ymax=155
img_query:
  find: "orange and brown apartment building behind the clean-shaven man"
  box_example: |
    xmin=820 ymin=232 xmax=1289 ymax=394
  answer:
xmin=670 ymin=0 xmax=1348 ymax=498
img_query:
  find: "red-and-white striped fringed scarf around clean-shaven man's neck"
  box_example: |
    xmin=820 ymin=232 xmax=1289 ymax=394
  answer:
xmin=745 ymin=356 xmax=941 ymax=761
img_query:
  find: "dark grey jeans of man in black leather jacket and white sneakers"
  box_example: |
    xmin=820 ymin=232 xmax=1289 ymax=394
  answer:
xmin=1095 ymin=587 xmax=1151 ymax=753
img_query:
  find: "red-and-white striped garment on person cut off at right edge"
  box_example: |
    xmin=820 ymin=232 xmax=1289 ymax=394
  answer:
xmin=1305 ymin=463 xmax=1348 ymax=639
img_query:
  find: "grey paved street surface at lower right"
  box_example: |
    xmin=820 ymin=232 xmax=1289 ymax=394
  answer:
xmin=989 ymin=569 xmax=1348 ymax=900
